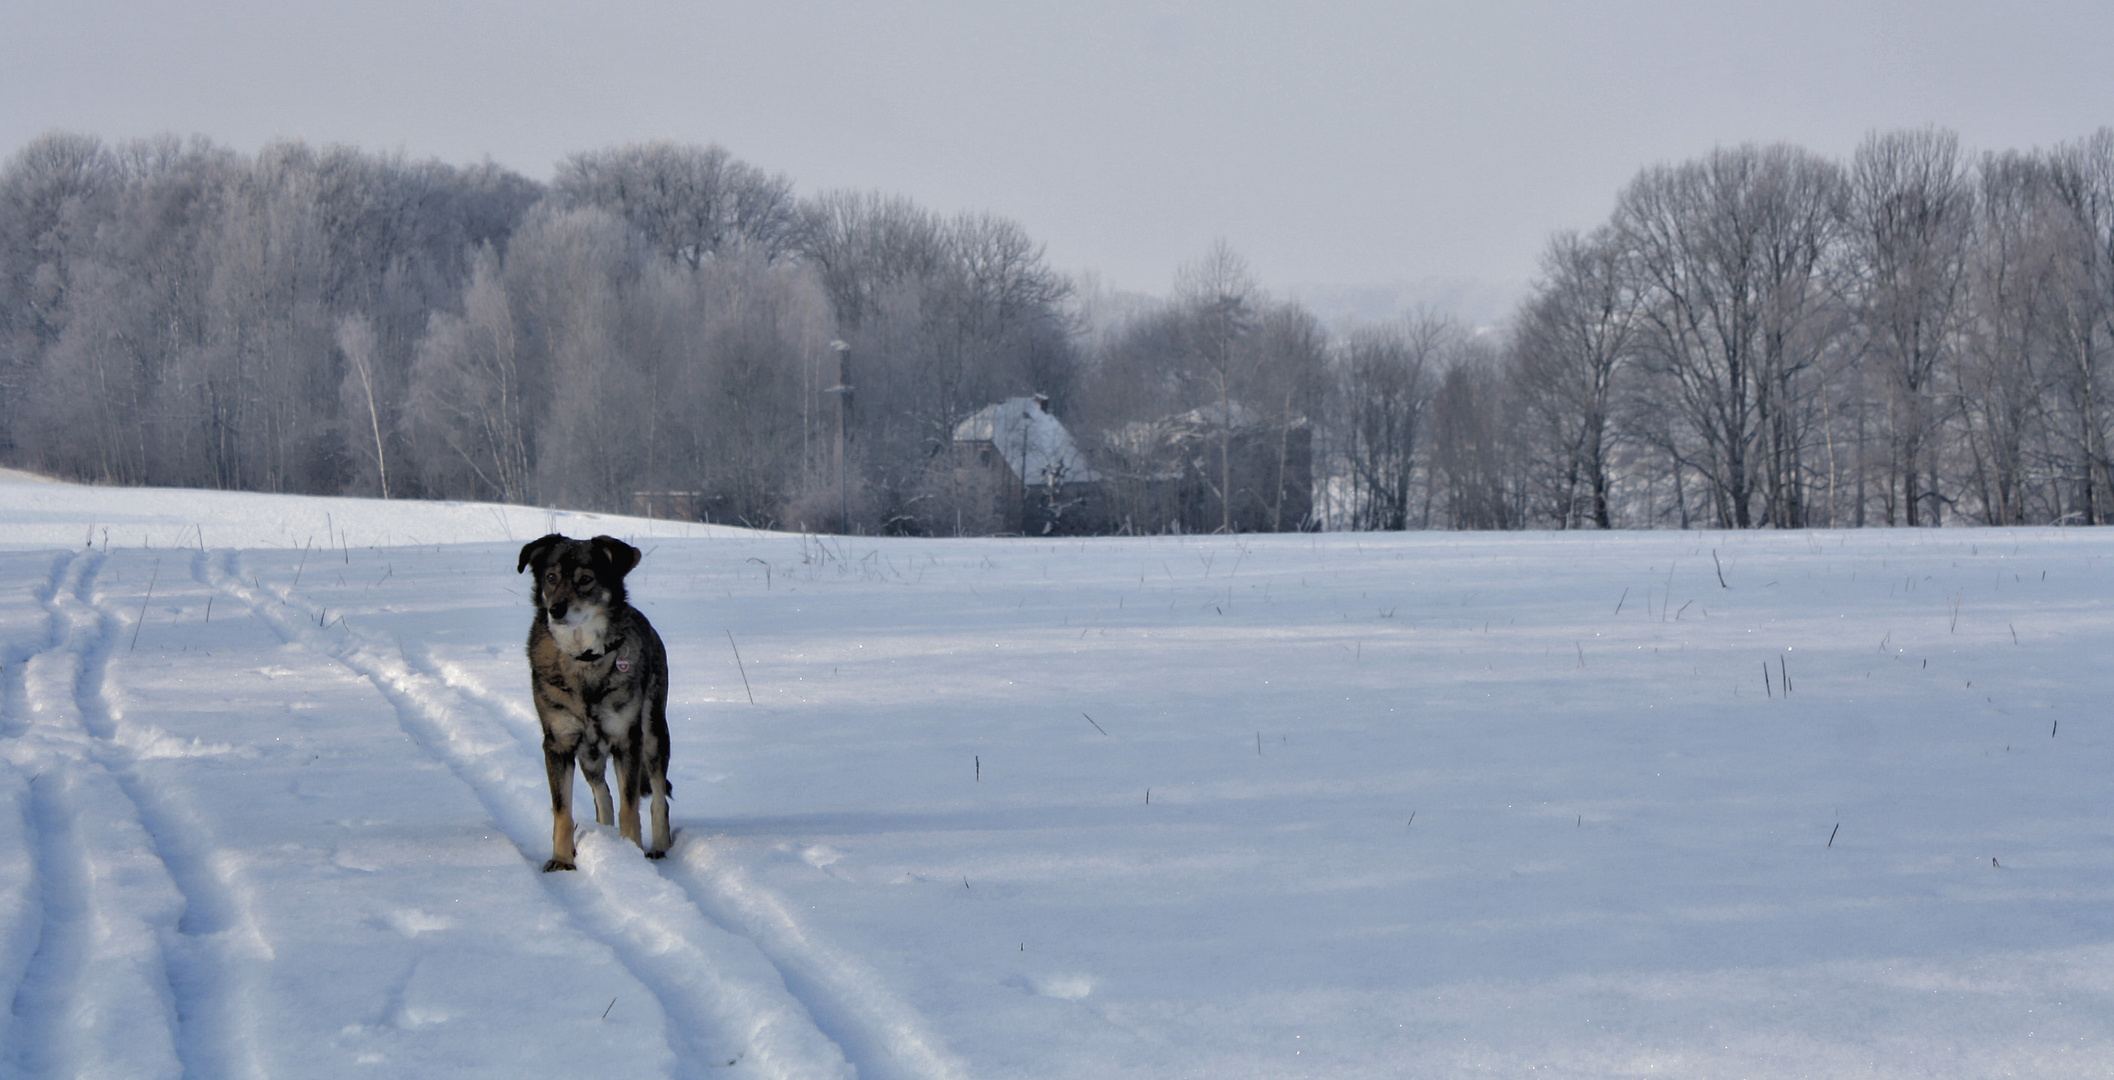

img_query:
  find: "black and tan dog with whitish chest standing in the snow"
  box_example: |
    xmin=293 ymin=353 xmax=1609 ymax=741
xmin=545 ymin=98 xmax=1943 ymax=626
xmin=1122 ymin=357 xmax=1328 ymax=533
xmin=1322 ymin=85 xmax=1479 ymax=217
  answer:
xmin=514 ymin=533 xmax=672 ymax=873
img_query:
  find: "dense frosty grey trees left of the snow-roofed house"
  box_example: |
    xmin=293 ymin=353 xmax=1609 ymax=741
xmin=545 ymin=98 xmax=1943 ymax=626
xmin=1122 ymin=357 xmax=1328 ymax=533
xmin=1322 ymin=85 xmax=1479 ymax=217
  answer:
xmin=0 ymin=133 xmax=1076 ymax=530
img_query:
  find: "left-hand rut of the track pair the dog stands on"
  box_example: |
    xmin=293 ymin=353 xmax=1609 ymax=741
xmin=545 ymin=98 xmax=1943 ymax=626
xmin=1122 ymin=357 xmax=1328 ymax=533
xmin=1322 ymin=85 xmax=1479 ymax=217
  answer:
xmin=194 ymin=554 xmax=854 ymax=1080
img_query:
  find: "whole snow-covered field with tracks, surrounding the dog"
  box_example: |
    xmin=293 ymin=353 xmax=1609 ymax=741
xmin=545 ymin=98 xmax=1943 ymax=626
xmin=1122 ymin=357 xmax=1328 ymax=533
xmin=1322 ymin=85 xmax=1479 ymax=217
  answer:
xmin=0 ymin=484 xmax=2114 ymax=1078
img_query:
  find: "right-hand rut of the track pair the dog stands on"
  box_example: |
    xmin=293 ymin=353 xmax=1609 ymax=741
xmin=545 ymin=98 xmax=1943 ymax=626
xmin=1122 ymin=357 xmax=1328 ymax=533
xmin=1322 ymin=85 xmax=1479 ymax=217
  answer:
xmin=404 ymin=645 xmax=968 ymax=1080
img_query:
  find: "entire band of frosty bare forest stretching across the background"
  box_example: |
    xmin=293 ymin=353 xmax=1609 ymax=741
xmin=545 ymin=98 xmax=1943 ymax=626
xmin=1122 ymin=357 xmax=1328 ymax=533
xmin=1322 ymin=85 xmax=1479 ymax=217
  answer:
xmin=0 ymin=129 xmax=2114 ymax=535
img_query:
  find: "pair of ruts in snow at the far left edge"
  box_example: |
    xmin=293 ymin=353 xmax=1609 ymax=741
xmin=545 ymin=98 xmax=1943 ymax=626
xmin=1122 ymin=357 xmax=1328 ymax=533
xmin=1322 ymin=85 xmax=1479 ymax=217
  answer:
xmin=8 ymin=552 xmax=276 ymax=1078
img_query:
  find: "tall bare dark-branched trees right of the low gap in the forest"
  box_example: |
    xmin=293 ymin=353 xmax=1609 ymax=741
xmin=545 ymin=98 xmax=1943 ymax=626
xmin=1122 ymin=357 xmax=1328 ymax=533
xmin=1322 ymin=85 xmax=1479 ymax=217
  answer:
xmin=1496 ymin=129 xmax=2114 ymax=528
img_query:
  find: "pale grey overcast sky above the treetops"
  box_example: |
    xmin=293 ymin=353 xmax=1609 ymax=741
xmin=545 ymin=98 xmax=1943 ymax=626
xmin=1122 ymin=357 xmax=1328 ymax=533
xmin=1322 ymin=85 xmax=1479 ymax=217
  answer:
xmin=0 ymin=0 xmax=2114 ymax=312
